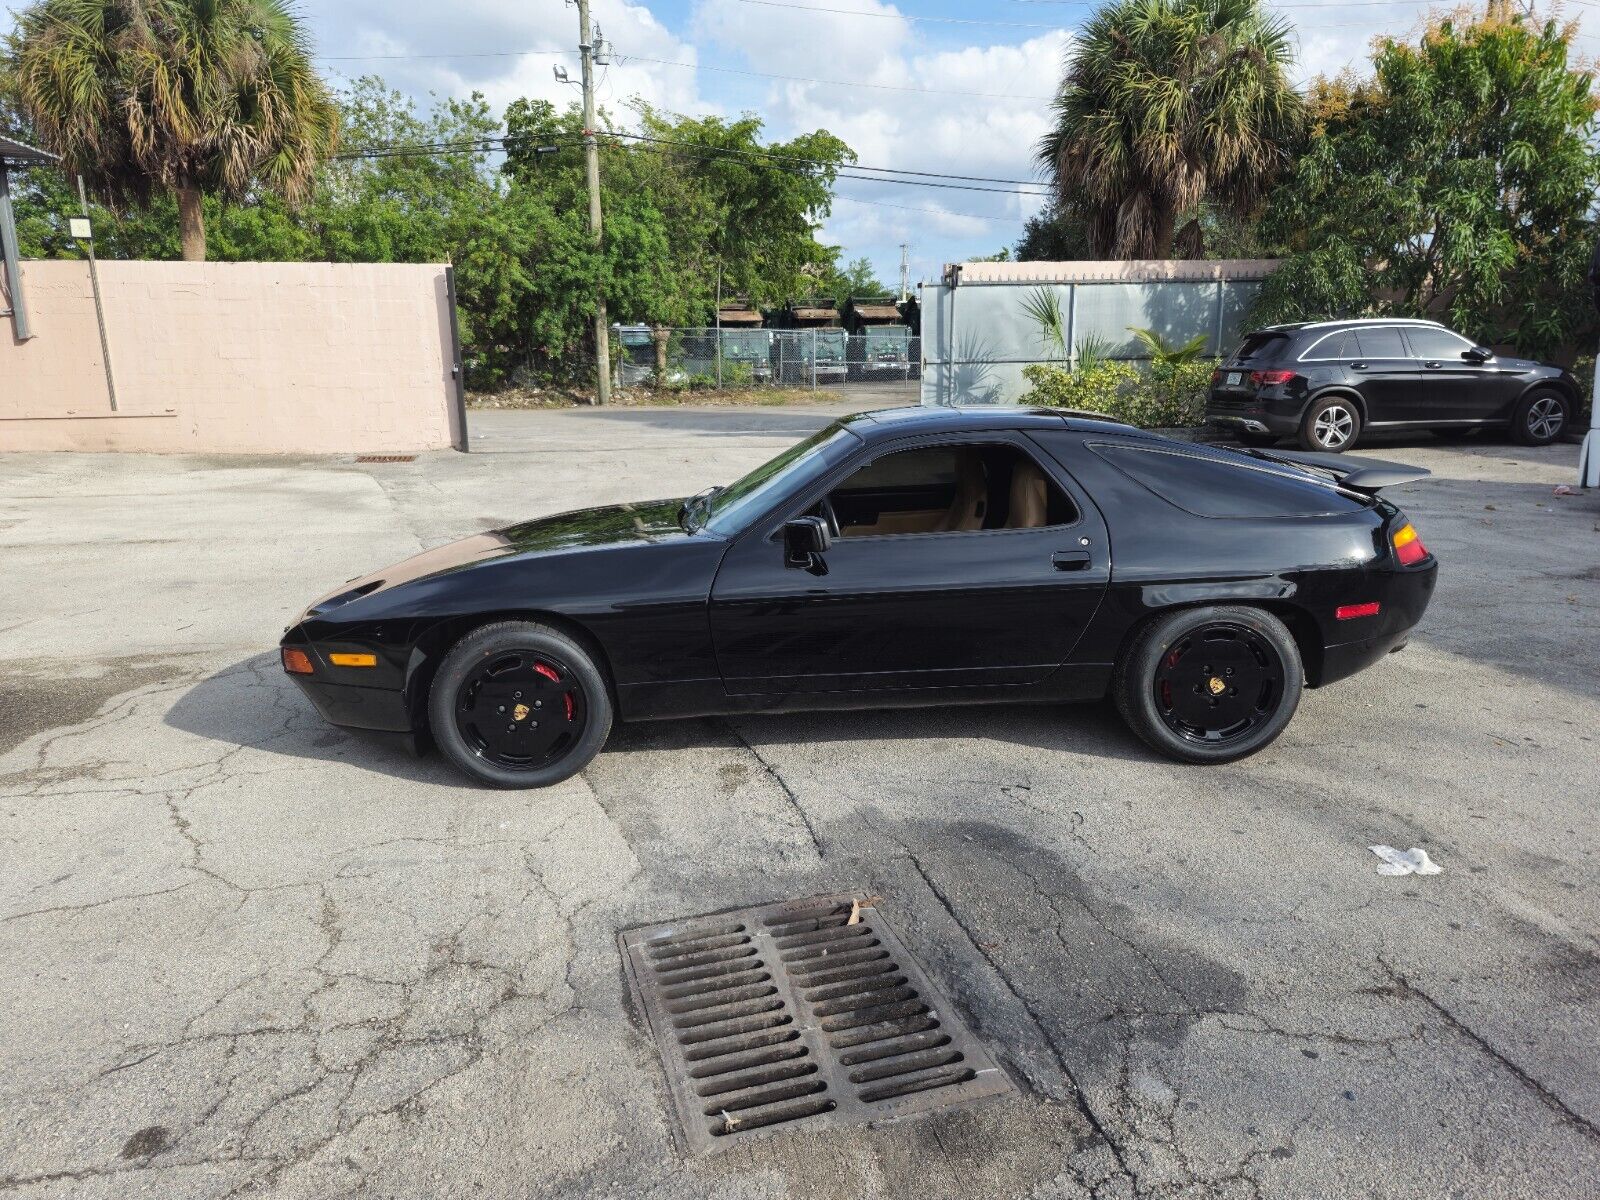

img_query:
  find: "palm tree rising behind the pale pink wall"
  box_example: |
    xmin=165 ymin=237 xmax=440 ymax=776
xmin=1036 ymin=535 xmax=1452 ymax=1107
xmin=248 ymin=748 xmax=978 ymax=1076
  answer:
xmin=0 ymin=0 xmax=339 ymax=262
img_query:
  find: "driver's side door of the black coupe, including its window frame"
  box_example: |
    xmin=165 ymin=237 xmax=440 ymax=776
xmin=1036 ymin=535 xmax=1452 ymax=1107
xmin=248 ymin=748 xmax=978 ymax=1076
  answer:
xmin=710 ymin=432 xmax=1110 ymax=696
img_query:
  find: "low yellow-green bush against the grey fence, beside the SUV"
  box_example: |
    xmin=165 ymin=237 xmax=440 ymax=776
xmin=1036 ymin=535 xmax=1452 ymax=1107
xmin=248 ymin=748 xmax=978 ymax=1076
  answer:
xmin=1022 ymin=362 xmax=1211 ymax=429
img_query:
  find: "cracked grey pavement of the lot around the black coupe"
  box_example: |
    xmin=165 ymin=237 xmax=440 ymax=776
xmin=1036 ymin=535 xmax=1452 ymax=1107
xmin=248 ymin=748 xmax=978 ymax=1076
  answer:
xmin=0 ymin=408 xmax=1600 ymax=1200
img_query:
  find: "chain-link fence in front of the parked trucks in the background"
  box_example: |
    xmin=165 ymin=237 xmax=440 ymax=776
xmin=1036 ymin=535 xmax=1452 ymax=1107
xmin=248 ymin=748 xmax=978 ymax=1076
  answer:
xmin=614 ymin=325 xmax=922 ymax=392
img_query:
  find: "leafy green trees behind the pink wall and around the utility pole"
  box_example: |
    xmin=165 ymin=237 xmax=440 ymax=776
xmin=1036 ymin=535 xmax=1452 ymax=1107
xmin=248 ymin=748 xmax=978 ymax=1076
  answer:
xmin=0 ymin=78 xmax=864 ymax=387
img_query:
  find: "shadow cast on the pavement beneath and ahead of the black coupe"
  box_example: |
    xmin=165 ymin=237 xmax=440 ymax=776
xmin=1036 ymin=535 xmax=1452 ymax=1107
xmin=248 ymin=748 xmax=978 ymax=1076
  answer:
xmin=165 ymin=654 xmax=1157 ymax=786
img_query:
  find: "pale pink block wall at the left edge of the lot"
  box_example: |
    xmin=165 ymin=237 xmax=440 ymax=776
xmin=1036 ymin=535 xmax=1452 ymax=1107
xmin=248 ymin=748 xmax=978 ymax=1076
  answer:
xmin=0 ymin=261 xmax=459 ymax=454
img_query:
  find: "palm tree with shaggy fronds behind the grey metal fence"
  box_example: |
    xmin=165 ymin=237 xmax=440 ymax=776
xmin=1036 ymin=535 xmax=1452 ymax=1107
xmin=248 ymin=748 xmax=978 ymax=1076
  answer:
xmin=1038 ymin=0 xmax=1302 ymax=258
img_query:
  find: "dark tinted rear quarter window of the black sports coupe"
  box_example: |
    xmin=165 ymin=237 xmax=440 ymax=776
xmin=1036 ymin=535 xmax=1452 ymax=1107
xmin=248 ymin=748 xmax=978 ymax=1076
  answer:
xmin=1090 ymin=443 xmax=1365 ymax=517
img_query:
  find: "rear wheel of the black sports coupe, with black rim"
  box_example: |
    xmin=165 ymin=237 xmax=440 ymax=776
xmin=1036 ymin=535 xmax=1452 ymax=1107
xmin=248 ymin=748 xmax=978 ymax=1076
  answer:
xmin=1112 ymin=605 xmax=1306 ymax=763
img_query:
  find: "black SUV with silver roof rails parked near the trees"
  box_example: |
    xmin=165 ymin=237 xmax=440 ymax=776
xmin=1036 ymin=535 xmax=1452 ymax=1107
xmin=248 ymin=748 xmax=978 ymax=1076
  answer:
xmin=1205 ymin=320 xmax=1578 ymax=451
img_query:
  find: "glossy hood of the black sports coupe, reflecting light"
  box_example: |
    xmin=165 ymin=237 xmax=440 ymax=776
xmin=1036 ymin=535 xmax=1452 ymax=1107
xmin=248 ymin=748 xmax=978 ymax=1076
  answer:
xmin=306 ymin=499 xmax=694 ymax=616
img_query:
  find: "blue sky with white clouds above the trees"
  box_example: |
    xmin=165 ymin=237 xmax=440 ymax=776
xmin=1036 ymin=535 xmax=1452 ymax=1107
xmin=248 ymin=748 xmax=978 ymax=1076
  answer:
xmin=9 ymin=0 xmax=1600 ymax=283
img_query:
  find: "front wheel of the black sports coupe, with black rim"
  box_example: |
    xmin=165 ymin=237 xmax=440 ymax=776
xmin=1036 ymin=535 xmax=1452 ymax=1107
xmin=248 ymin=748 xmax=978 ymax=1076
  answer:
xmin=427 ymin=621 xmax=613 ymax=787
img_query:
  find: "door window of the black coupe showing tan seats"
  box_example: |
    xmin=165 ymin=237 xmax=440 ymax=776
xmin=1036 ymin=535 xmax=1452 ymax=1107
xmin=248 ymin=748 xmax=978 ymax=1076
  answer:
xmin=818 ymin=445 xmax=1077 ymax=538
